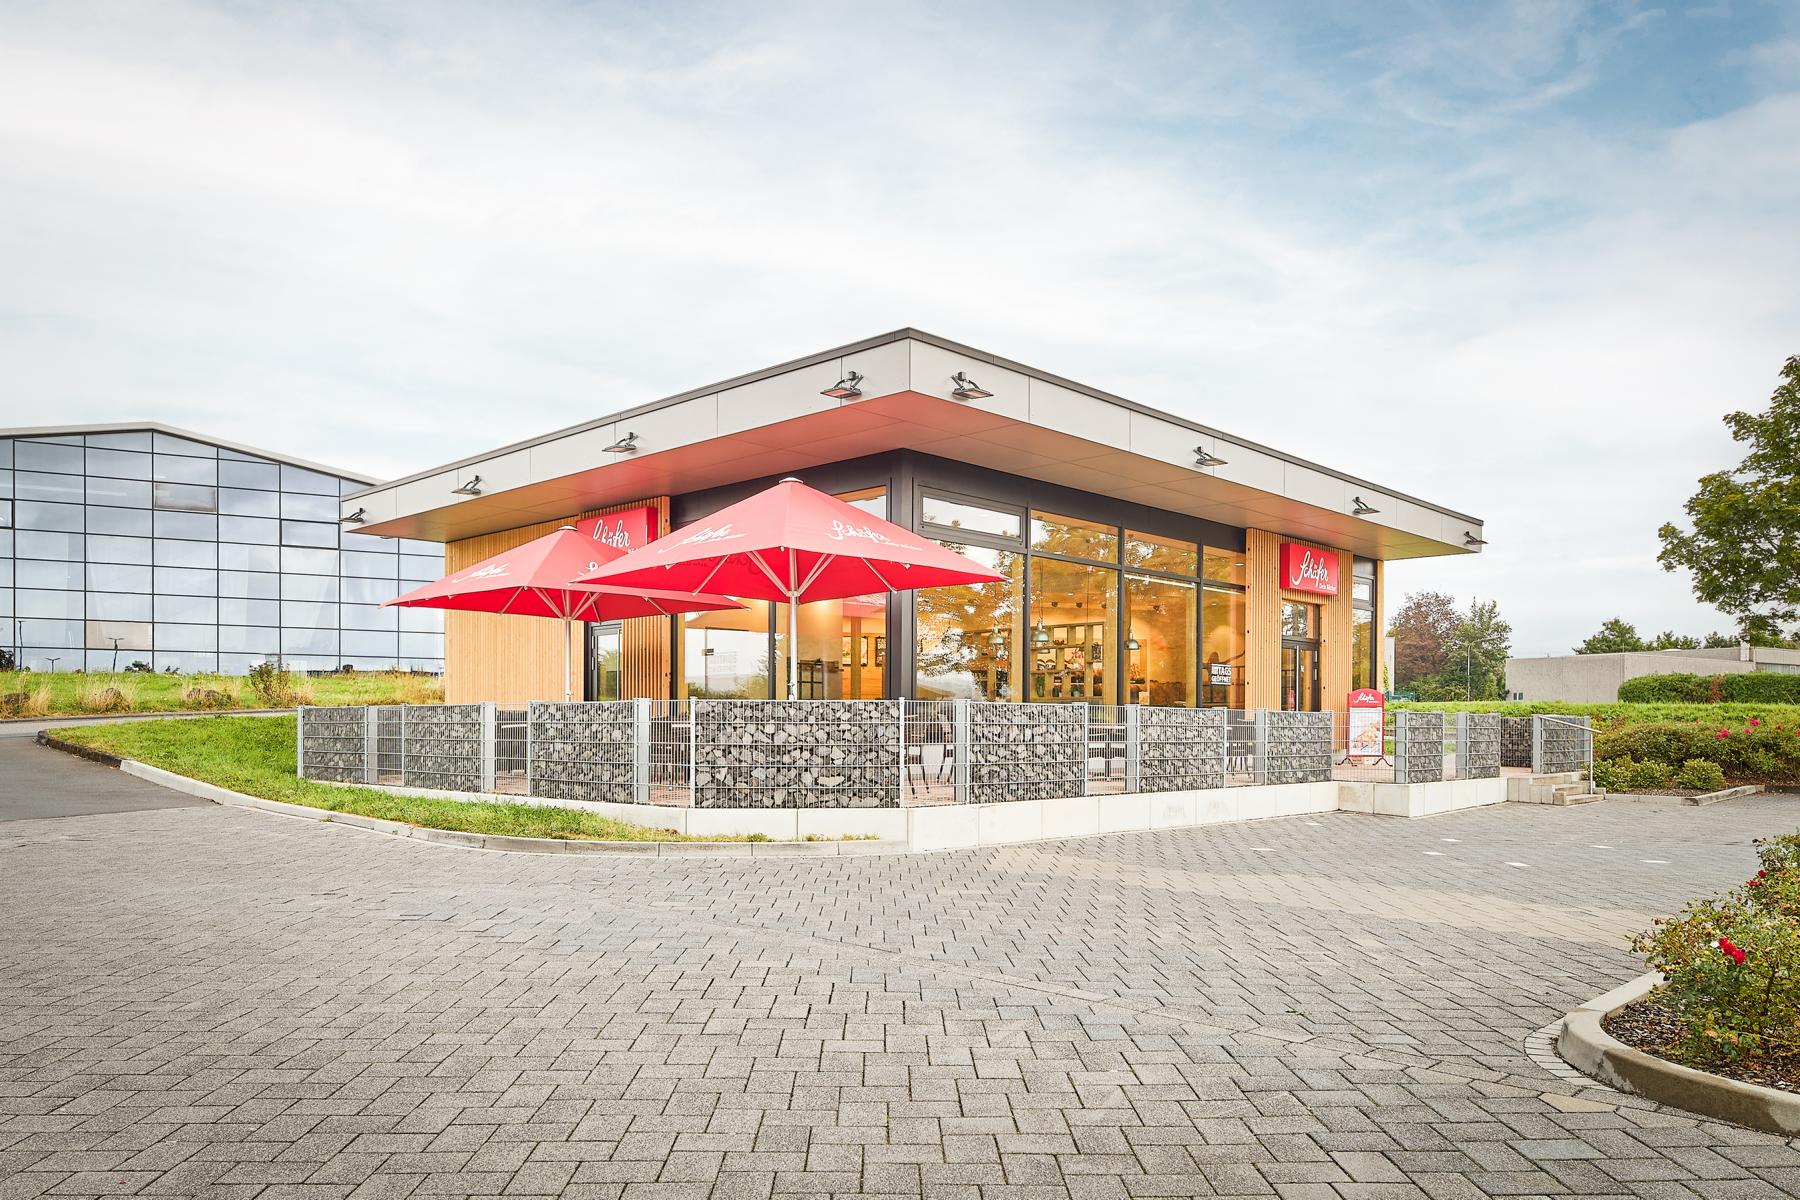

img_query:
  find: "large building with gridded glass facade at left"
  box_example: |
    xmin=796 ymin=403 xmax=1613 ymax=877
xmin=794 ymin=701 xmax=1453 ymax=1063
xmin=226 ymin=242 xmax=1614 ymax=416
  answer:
xmin=0 ymin=426 xmax=443 ymax=675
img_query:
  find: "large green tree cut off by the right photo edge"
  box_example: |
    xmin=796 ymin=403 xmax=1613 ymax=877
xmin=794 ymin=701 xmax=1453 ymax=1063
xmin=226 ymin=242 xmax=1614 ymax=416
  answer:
xmin=1656 ymin=354 xmax=1800 ymax=633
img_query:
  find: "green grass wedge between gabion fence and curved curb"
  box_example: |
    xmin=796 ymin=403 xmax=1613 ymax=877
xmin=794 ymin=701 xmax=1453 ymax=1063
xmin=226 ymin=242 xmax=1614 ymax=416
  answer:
xmin=56 ymin=716 xmax=716 ymax=842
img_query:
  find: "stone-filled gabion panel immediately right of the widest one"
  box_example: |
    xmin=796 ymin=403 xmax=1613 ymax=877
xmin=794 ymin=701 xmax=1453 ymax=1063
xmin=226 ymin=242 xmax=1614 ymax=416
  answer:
xmin=968 ymin=703 xmax=1087 ymax=804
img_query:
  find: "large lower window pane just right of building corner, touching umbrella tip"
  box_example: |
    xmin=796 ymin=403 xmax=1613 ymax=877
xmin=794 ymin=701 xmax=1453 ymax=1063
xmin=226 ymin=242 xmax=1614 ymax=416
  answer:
xmin=914 ymin=542 xmax=1024 ymax=700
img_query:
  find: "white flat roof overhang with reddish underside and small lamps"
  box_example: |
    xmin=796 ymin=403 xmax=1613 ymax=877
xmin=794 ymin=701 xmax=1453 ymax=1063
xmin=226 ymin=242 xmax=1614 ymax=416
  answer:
xmin=344 ymin=329 xmax=1483 ymax=560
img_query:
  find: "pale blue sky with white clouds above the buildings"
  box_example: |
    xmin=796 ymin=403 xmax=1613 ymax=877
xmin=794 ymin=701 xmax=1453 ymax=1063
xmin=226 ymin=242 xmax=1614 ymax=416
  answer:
xmin=0 ymin=0 xmax=1800 ymax=653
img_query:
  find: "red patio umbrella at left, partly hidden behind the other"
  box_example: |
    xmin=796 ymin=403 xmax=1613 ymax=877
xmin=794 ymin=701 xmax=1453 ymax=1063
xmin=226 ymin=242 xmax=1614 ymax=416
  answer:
xmin=382 ymin=525 xmax=743 ymax=700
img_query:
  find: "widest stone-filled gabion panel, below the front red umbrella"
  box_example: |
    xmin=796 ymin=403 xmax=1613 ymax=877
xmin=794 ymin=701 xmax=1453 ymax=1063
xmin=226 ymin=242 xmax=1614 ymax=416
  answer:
xmin=691 ymin=700 xmax=902 ymax=808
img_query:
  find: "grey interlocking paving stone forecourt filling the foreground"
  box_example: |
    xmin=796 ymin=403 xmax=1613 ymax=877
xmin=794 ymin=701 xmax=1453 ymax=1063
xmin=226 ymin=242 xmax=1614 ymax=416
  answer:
xmin=0 ymin=755 xmax=1800 ymax=1200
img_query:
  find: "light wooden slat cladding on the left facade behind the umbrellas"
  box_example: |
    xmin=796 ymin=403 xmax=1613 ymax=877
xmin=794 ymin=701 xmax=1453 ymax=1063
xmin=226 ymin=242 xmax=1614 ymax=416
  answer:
xmin=445 ymin=497 xmax=670 ymax=703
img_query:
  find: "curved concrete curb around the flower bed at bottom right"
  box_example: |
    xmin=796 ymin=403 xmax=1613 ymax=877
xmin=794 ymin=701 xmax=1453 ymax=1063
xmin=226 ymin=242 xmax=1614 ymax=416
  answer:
xmin=1557 ymin=972 xmax=1800 ymax=1137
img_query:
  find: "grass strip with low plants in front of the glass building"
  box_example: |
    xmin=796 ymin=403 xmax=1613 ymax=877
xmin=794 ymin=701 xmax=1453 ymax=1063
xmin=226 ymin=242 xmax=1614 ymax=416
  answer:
xmin=0 ymin=671 xmax=443 ymax=716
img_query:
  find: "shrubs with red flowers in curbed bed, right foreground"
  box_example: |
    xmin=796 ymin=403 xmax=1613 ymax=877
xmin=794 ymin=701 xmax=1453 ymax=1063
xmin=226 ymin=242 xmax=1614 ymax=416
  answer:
xmin=1627 ymin=835 xmax=1800 ymax=1090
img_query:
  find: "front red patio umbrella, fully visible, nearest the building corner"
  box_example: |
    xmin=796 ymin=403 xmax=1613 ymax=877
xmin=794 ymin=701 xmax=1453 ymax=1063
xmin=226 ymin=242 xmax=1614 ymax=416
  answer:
xmin=576 ymin=479 xmax=1006 ymax=700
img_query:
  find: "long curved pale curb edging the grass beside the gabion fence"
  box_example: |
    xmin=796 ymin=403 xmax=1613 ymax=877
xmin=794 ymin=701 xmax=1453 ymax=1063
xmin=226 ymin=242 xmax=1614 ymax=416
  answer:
xmin=38 ymin=730 xmax=913 ymax=858
